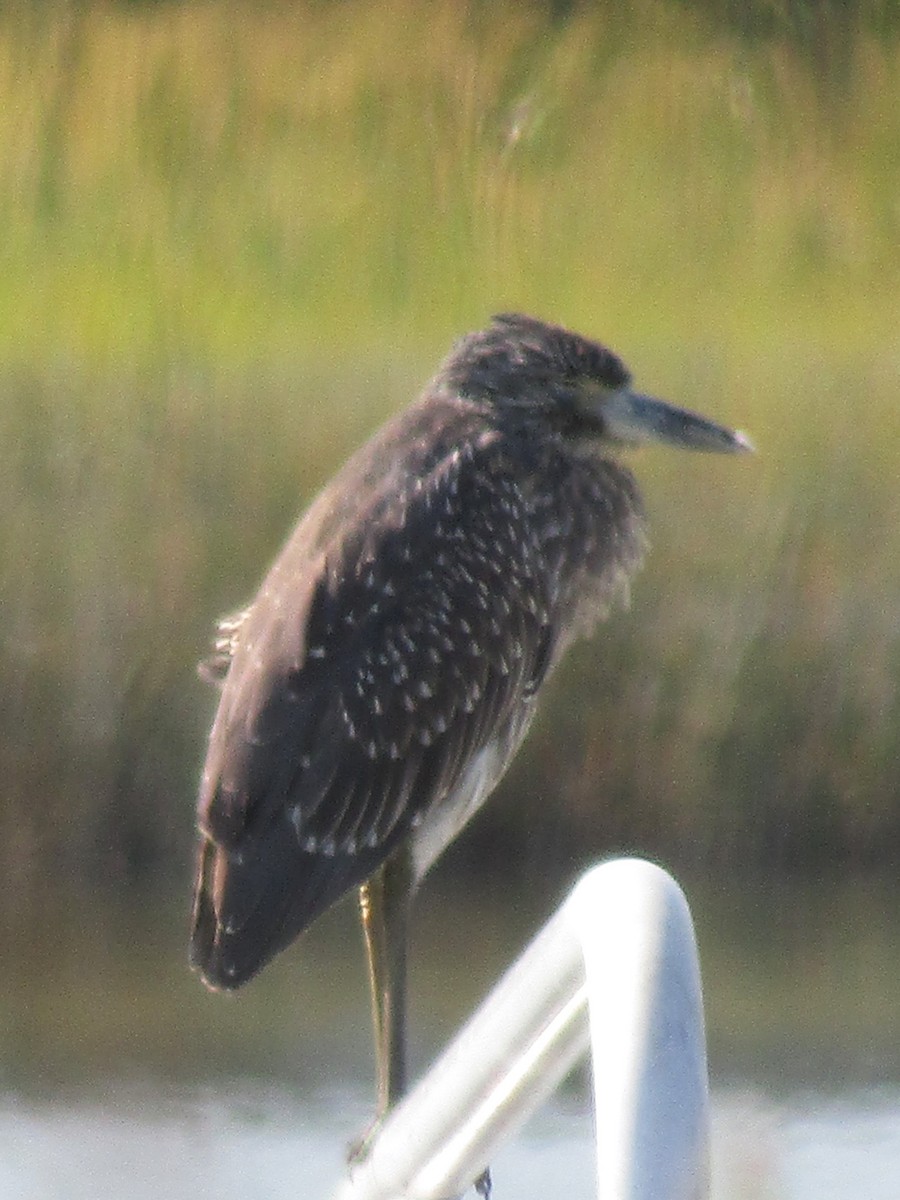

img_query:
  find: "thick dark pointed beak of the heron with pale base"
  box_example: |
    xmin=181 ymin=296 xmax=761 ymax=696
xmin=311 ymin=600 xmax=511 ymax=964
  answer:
xmin=600 ymin=388 xmax=754 ymax=454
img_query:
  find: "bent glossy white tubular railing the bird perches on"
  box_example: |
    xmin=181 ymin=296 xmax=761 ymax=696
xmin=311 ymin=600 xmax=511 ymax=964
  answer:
xmin=336 ymin=859 xmax=709 ymax=1200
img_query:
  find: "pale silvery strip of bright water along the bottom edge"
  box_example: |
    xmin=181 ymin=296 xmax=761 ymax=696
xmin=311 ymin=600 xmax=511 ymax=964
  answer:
xmin=0 ymin=1080 xmax=900 ymax=1200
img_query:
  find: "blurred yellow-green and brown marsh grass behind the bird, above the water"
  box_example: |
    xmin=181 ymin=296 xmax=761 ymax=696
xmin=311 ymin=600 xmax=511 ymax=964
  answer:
xmin=0 ymin=0 xmax=900 ymax=917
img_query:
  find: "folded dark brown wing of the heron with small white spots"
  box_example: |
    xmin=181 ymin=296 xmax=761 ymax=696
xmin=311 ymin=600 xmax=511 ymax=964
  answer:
xmin=192 ymin=433 xmax=552 ymax=986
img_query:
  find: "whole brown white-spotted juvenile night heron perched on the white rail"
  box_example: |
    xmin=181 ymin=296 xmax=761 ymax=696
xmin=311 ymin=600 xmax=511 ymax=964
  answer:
xmin=191 ymin=314 xmax=750 ymax=1147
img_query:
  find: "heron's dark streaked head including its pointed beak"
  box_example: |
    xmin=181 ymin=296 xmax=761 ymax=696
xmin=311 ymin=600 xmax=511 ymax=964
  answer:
xmin=439 ymin=313 xmax=752 ymax=454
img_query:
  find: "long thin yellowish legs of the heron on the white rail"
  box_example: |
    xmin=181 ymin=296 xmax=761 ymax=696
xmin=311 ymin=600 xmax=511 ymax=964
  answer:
xmin=359 ymin=850 xmax=413 ymax=1137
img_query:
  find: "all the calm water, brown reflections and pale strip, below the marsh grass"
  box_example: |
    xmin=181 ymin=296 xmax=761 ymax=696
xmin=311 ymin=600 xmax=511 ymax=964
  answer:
xmin=0 ymin=878 xmax=900 ymax=1200
